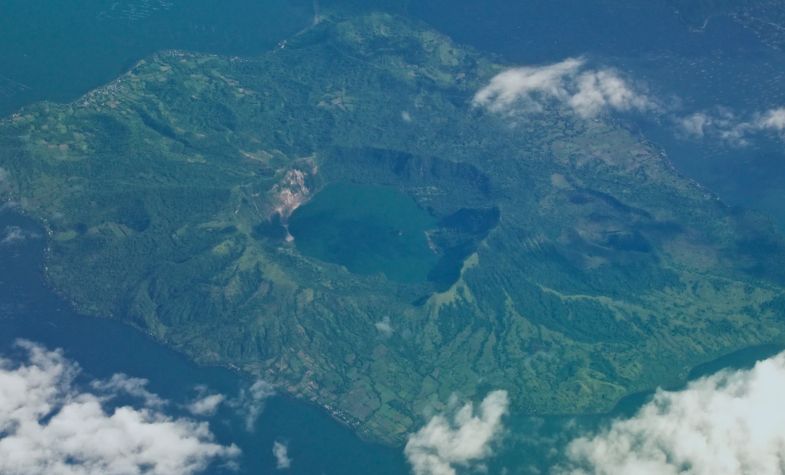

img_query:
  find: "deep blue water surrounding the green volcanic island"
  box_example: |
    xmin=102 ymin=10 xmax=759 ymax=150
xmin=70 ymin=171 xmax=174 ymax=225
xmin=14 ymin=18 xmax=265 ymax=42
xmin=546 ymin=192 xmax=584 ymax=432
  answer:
xmin=0 ymin=0 xmax=785 ymax=474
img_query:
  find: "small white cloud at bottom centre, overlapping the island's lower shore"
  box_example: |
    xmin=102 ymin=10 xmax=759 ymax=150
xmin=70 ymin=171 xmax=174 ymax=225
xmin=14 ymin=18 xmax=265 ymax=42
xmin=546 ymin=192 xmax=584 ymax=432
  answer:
xmin=404 ymin=391 xmax=509 ymax=475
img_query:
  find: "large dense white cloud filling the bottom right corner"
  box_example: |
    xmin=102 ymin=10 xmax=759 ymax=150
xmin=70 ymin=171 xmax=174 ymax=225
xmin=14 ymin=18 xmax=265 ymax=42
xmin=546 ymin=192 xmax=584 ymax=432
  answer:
xmin=556 ymin=354 xmax=785 ymax=475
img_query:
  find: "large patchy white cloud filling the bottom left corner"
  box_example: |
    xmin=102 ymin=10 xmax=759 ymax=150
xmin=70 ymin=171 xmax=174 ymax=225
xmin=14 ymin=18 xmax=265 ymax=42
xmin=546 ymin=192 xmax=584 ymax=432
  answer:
xmin=0 ymin=341 xmax=239 ymax=475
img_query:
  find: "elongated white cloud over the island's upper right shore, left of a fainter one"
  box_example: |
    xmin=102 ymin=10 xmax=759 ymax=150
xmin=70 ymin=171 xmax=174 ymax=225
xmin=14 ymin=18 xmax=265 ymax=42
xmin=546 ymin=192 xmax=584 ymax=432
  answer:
xmin=473 ymin=58 xmax=657 ymax=118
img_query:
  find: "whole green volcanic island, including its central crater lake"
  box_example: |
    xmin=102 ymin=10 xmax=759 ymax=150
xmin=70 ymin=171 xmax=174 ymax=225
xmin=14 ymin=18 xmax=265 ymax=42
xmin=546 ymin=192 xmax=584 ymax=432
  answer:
xmin=0 ymin=15 xmax=785 ymax=441
